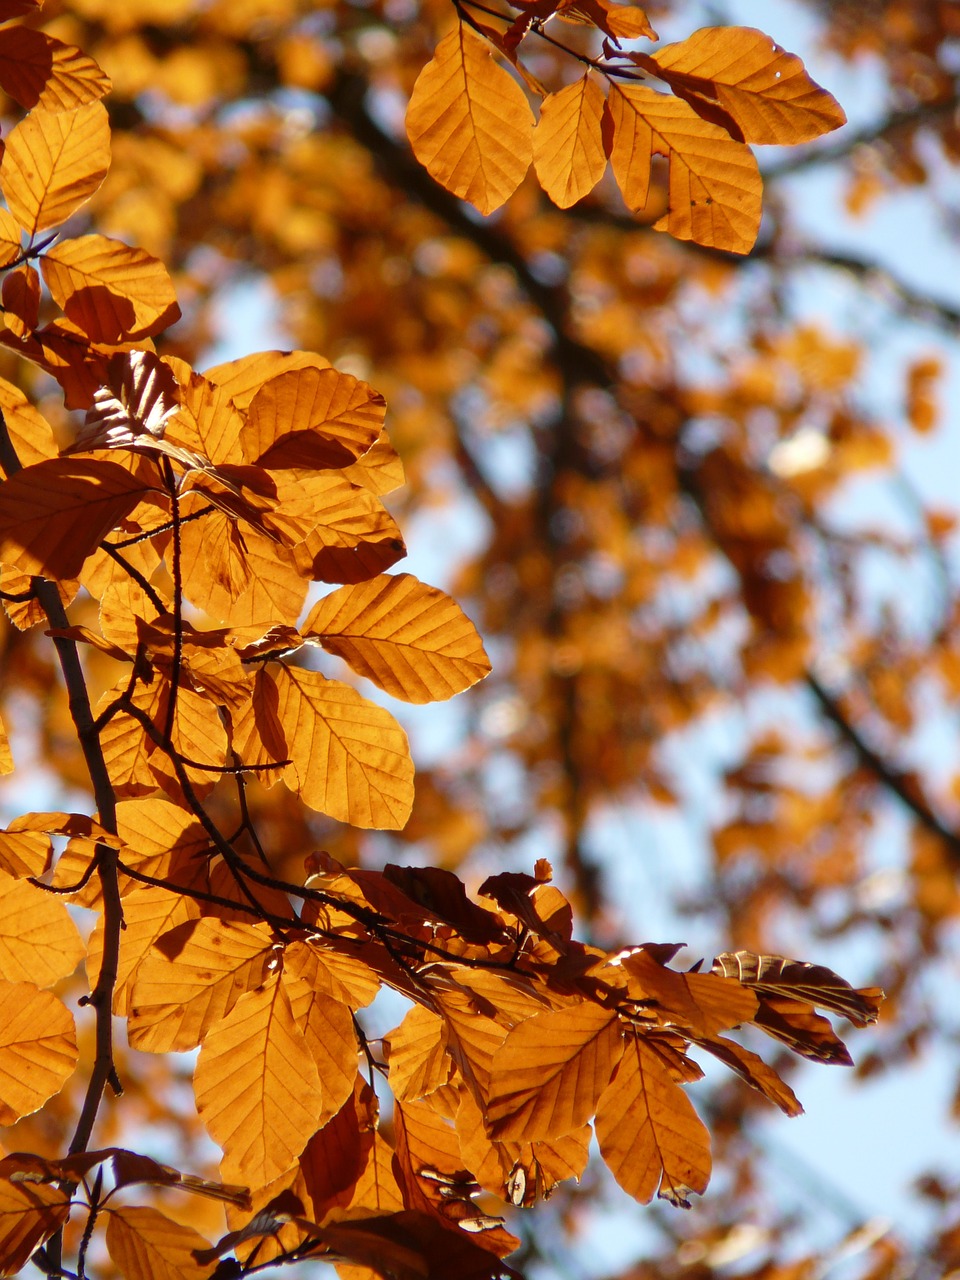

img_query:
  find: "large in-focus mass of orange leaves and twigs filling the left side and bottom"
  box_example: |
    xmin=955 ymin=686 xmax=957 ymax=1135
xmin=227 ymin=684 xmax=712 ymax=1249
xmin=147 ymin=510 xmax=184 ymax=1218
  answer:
xmin=0 ymin=0 xmax=901 ymax=1280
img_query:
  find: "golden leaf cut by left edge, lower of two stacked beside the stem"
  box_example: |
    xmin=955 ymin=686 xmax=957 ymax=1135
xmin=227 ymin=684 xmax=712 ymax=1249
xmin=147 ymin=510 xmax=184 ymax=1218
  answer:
xmin=0 ymin=982 xmax=78 ymax=1124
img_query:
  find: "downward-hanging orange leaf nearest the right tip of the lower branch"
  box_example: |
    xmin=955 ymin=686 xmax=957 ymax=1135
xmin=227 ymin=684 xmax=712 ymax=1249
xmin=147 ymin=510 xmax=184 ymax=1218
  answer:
xmin=595 ymin=1036 xmax=710 ymax=1208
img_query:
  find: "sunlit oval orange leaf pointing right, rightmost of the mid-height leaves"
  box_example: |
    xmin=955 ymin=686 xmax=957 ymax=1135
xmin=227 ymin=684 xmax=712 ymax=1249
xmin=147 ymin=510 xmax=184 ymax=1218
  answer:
xmin=301 ymin=573 xmax=490 ymax=703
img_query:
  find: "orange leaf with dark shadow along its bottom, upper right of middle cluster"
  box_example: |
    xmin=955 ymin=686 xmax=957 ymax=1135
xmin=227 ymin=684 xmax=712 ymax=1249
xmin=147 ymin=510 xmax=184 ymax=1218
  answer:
xmin=242 ymin=369 xmax=387 ymax=470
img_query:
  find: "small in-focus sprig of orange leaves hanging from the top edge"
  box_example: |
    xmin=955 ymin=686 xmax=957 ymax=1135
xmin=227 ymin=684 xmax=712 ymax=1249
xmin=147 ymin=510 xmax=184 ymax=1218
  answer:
xmin=407 ymin=0 xmax=846 ymax=253
